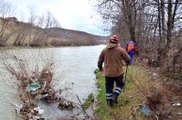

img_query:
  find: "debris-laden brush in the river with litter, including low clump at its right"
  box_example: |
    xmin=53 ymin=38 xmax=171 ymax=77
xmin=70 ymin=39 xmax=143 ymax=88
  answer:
xmin=4 ymin=56 xmax=74 ymax=120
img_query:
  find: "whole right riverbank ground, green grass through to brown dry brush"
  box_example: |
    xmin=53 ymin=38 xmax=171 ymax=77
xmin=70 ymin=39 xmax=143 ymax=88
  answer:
xmin=95 ymin=65 xmax=182 ymax=120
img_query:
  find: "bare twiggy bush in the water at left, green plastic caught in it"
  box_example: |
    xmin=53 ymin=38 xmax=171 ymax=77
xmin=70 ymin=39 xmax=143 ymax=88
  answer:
xmin=2 ymin=53 xmax=56 ymax=120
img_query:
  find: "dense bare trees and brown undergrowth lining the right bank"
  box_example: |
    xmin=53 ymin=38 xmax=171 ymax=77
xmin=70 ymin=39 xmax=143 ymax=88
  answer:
xmin=96 ymin=0 xmax=182 ymax=72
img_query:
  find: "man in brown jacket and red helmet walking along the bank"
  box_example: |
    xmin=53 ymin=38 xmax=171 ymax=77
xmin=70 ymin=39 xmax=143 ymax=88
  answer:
xmin=98 ymin=35 xmax=130 ymax=106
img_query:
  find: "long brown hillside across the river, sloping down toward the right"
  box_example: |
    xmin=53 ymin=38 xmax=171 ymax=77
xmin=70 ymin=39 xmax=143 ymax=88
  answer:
xmin=0 ymin=18 xmax=107 ymax=47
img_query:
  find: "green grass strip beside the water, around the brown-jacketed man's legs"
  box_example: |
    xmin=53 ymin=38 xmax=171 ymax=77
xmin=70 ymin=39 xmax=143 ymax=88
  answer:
xmin=96 ymin=67 xmax=147 ymax=120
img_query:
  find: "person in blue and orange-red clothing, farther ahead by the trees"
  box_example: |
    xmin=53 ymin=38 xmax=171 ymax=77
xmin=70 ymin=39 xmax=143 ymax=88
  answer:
xmin=126 ymin=41 xmax=136 ymax=64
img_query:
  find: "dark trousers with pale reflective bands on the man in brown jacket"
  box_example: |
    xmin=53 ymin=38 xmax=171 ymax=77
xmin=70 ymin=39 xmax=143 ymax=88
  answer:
xmin=105 ymin=75 xmax=124 ymax=100
